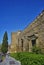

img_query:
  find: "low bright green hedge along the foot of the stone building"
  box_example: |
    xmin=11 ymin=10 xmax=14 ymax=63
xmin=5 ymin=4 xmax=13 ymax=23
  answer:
xmin=10 ymin=52 xmax=44 ymax=65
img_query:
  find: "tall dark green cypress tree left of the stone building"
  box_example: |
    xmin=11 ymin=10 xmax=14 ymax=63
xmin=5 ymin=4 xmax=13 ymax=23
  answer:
xmin=1 ymin=32 xmax=8 ymax=54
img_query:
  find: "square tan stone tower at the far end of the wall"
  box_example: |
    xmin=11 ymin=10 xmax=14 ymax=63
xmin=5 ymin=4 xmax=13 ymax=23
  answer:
xmin=9 ymin=31 xmax=20 ymax=53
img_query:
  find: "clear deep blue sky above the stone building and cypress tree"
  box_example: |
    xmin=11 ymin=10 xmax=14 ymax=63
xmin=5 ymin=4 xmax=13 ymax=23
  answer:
xmin=0 ymin=0 xmax=44 ymax=43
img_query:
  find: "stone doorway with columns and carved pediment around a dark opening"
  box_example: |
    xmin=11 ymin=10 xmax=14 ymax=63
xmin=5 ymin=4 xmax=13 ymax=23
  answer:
xmin=27 ymin=35 xmax=38 ymax=52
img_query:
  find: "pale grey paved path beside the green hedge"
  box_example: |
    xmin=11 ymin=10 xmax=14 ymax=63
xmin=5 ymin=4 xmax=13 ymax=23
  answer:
xmin=0 ymin=56 xmax=21 ymax=65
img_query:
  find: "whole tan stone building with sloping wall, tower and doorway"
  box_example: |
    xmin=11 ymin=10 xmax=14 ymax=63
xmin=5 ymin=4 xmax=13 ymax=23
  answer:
xmin=10 ymin=11 xmax=44 ymax=52
